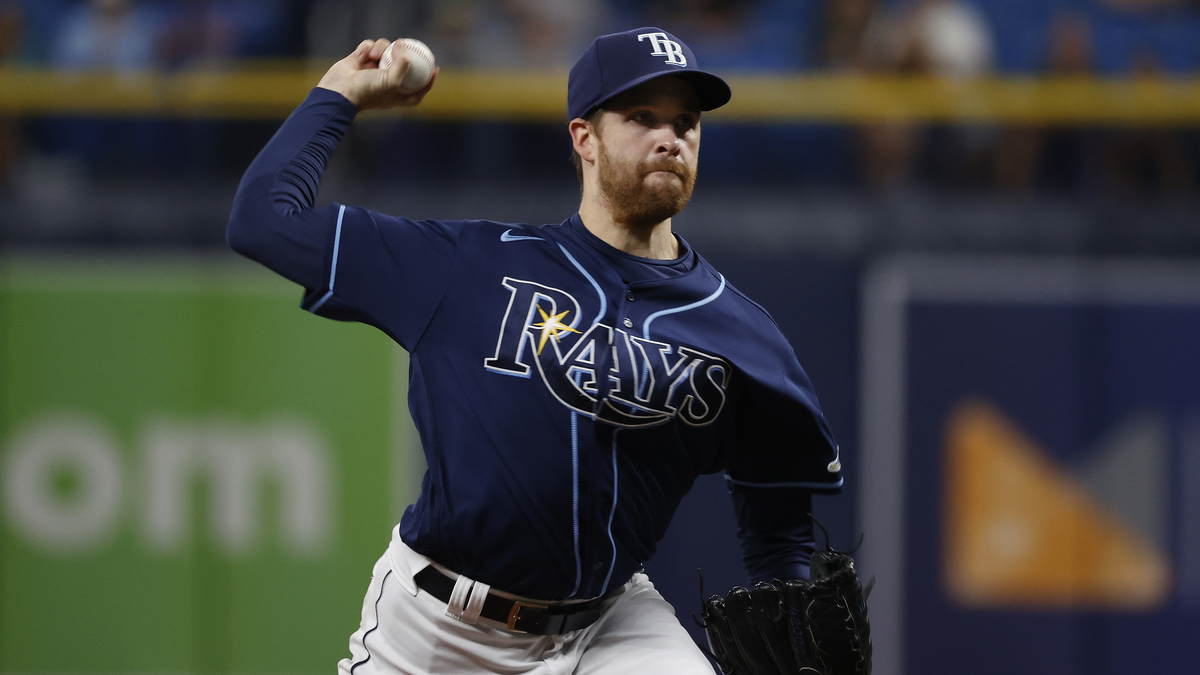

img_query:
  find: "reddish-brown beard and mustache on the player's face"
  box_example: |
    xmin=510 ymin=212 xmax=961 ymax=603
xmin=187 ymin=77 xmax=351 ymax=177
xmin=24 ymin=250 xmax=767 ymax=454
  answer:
xmin=596 ymin=143 xmax=696 ymax=227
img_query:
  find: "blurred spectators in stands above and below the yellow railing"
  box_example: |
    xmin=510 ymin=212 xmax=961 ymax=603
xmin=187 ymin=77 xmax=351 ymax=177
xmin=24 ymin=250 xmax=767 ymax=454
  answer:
xmin=0 ymin=0 xmax=1200 ymax=196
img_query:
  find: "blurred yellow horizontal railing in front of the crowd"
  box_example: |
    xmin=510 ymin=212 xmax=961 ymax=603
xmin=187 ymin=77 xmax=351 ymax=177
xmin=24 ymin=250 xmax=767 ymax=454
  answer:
xmin=0 ymin=65 xmax=1200 ymax=126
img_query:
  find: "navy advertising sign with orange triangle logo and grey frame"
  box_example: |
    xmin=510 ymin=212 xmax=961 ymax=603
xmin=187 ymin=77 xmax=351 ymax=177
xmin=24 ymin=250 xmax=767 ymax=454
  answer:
xmin=860 ymin=257 xmax=1200 ymax=675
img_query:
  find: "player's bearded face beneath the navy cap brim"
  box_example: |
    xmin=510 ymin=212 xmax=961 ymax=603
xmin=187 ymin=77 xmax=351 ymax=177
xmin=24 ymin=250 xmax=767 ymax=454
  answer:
xmin=596 ymin=77 xmax=700 ymax=226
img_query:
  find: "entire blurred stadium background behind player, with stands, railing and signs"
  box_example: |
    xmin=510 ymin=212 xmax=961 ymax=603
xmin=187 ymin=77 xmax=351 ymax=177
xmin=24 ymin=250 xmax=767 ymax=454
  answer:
xmin=0 ymin=0 xmax=1200 ymax=675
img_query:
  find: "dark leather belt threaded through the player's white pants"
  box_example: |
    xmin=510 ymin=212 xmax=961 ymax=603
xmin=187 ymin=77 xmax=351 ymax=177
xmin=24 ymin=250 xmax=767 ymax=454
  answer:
xmin=413 ymin=566 xmax=607 ymax=635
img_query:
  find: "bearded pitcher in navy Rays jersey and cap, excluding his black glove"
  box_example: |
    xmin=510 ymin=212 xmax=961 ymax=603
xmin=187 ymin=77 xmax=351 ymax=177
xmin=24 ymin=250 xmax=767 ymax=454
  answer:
xmin=228 ymin=28 xmax=841 ymax=675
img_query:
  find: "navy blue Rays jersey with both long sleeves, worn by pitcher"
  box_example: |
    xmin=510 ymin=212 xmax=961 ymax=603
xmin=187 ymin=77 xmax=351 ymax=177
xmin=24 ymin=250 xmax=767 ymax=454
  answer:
xmin=228 ymin=89 xmax=841 ymax=599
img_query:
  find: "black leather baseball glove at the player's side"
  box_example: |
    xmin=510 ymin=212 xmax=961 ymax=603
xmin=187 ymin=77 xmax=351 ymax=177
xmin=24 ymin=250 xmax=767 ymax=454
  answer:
xmin=697 ymin=519 xmax=875 ymax=675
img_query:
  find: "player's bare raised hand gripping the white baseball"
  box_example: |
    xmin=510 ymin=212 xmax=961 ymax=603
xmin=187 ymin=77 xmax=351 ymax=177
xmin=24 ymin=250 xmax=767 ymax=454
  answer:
xmin=317 ymin=38 xmax=438 ymax=110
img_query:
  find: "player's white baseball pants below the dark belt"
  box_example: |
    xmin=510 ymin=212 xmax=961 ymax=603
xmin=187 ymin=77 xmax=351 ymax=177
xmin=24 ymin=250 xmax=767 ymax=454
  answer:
xmin=337 ymin=533 xmax=714 ymax=675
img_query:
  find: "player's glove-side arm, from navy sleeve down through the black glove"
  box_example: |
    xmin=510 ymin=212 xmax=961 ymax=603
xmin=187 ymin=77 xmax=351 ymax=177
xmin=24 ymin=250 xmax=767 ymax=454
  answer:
xmin=701 ymin=314 xmax=871 ymax=675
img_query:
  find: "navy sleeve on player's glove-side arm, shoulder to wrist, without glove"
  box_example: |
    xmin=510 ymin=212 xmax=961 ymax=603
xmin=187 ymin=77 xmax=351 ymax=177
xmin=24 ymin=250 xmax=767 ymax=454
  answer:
xmin=725 ymin=297 xmax=842 ymax=581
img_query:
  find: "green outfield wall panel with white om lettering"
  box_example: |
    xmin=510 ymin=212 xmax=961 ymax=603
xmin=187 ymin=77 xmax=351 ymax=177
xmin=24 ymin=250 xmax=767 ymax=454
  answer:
xmin=0 ymin=255 xmax=421 ymax=675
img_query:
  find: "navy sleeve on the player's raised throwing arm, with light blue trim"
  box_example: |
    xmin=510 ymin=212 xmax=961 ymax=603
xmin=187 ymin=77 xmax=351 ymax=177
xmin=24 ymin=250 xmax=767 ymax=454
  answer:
xmin=227 ymin=88 xmax=462 ymax=350
